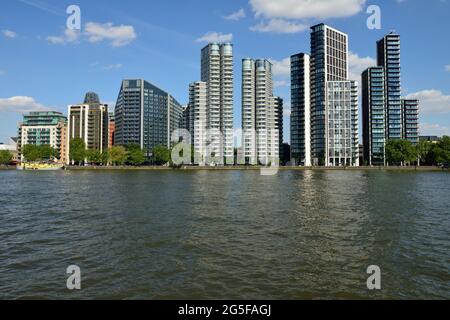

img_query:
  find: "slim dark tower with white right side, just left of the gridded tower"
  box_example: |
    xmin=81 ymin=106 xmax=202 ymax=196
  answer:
xmin=291 ymin=53 xmax=311 ymax=166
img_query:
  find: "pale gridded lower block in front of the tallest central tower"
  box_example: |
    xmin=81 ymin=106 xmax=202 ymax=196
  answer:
xmin=325 ymin=81 xmax=359 ymax=166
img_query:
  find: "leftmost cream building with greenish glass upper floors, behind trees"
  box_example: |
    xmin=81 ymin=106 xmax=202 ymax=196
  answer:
xmin=17 ymin=111 xmax=67 ymax=162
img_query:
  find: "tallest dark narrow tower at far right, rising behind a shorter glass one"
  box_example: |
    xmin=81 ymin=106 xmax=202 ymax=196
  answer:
xmin=377 ymin=32 xmax=403 ymax=140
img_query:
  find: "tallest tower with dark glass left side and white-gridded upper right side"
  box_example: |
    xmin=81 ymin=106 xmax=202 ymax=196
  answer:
xmin=310 ymin=23 xmax=348 ymax=165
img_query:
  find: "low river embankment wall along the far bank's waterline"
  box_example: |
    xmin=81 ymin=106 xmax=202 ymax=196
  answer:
xmin=0 ymin=165 xmax=450 ymax=172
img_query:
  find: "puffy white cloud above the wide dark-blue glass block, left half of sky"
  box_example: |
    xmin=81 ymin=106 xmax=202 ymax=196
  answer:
xmin=84 ymin=22 xmax=137 ymax=47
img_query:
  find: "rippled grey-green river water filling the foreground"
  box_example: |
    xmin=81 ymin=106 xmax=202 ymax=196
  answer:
xmin=0 ymin=171 xmax=450 ymax=299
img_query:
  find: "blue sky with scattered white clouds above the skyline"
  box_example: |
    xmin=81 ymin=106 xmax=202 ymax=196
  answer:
xmin=0 ymin=0 xmax=450 ymax=143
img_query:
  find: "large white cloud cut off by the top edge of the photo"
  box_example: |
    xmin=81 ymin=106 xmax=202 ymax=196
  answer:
xmin=250 ymin=0 xmax=366 ymax=19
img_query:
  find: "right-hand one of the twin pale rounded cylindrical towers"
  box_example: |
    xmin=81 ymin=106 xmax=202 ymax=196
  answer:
xmin=242 ymin=59 xmax=282 ymax=165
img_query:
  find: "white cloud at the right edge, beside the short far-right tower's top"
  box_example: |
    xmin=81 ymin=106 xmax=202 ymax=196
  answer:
xmin=406 ymin=89 xmax=450 ymax=114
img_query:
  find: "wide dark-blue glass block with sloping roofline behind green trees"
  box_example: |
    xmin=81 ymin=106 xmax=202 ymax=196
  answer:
xmin=115 ymin=79 xmax=183 ymax=158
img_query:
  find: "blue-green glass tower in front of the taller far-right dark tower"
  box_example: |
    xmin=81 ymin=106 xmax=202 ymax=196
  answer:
xmin=362 ymin=67 xmax=386 ymax=166
